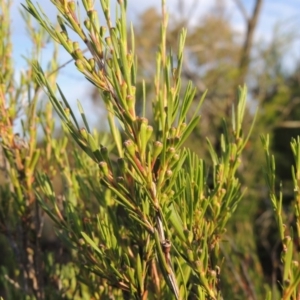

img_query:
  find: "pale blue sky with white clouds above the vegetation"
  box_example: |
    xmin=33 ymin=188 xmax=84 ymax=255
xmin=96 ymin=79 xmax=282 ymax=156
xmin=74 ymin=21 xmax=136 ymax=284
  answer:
xmin=7 ymin=0 xmax=300 ymax=126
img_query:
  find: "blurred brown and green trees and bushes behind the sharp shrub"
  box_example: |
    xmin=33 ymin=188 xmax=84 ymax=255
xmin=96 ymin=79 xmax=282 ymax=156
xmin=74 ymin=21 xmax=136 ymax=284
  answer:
xmin=0 ymin=0 xmax=300 ymax=300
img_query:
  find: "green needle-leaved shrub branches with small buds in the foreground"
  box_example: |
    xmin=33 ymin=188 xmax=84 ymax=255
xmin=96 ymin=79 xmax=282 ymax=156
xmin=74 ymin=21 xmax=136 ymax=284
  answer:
xmin=0 ymin=0 xmax=300 ymax=299
